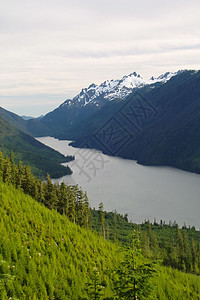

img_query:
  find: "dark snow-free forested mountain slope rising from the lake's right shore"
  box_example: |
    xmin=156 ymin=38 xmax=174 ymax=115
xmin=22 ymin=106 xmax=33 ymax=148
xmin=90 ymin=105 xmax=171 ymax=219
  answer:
xmin=69 ymin=71 xmax=200 ymax=173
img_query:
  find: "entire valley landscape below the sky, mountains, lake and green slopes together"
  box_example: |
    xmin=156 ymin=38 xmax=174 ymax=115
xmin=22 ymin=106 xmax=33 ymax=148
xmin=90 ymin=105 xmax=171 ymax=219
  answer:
xmin=0 ymin=70 xmax=200 ymax=300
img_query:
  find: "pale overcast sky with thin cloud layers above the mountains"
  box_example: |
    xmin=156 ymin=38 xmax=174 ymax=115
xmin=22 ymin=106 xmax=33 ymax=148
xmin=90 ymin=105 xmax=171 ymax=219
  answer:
xmin=0 ymin=0 xmax=200 ymax=117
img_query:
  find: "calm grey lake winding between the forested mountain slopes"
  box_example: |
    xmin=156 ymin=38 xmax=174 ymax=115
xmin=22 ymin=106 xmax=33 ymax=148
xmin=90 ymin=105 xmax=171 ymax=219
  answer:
xmin=37 ymin=137 xmax=200 ymax=229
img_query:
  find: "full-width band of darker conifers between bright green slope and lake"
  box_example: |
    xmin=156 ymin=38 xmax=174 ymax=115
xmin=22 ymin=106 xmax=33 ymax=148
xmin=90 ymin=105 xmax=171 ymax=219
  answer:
xmin=0 ymin=152 xmax=200 ymax=275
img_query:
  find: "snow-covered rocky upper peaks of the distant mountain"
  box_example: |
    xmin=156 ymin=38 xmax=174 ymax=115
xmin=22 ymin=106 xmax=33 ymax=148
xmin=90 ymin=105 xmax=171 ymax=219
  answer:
xmin=61 ymin=72 xmax=178 ymax=107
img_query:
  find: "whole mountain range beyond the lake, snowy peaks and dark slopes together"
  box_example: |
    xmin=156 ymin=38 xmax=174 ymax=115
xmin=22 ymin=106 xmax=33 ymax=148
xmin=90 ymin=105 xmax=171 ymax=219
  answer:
xmin=0 ymin=70 xmax=200 ymax=173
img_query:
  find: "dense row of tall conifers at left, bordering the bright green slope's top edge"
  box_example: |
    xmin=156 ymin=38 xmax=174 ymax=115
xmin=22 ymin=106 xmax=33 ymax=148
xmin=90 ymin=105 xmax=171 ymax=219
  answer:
xmin=0 ymin=152 xmax=90 ymax=228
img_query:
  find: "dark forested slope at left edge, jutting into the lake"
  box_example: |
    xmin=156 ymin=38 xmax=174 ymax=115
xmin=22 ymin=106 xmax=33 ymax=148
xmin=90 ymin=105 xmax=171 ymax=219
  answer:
xmin=0 ymin=117 xmax=72 ymax=177
